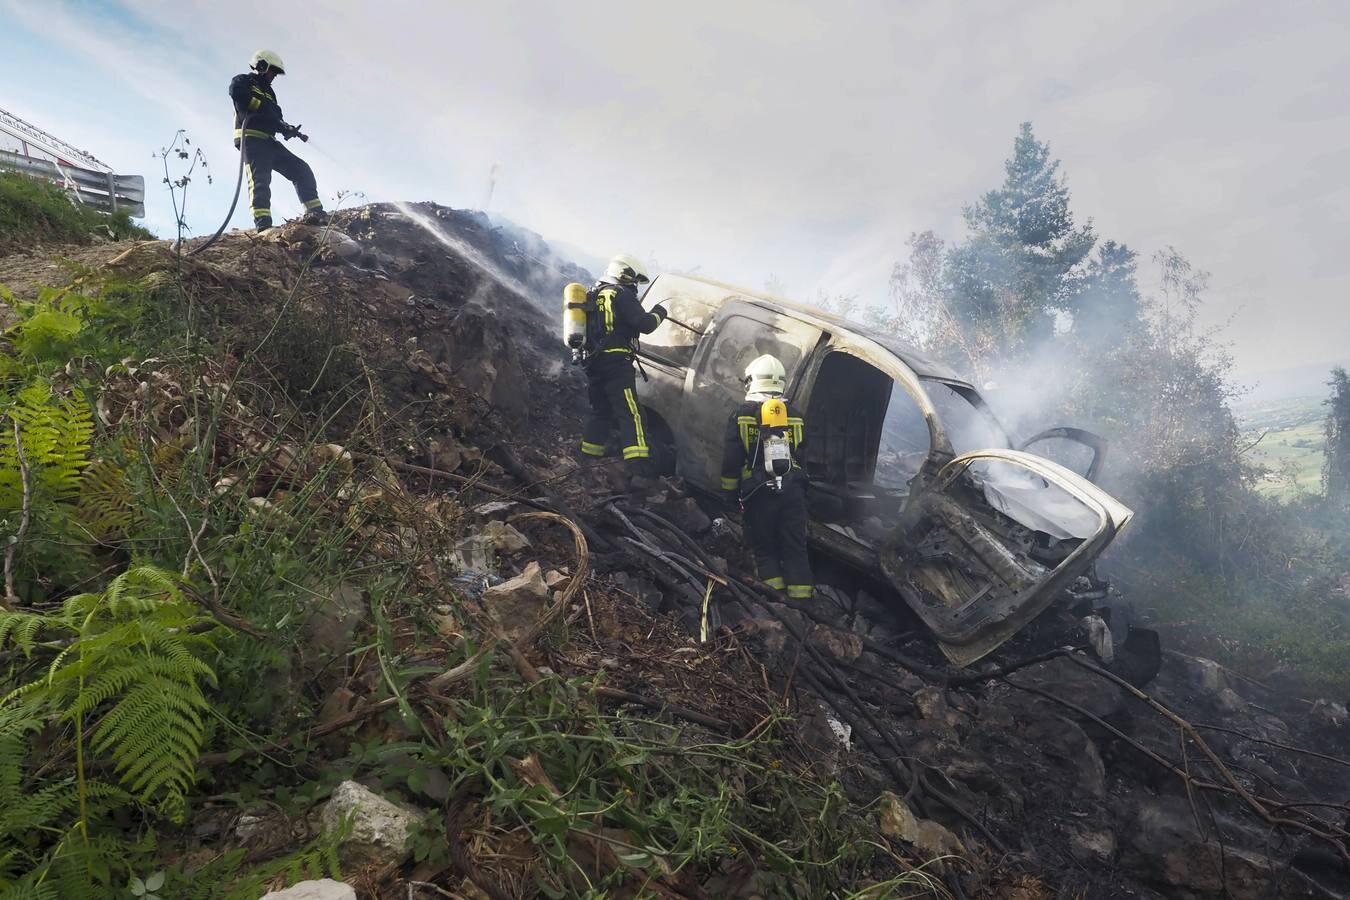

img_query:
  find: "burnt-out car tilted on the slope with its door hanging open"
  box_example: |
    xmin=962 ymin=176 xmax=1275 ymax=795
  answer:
xmin=639 ymin=274 xmax=1133 ymax=665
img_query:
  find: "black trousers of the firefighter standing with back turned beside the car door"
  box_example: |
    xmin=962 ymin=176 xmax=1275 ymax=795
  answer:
xmin=744 ymin=476 xmax=815 ymax=600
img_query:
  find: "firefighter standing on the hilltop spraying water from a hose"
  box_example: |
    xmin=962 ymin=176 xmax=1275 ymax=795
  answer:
xmin=230 ymin=50 xmax=327 ymax=231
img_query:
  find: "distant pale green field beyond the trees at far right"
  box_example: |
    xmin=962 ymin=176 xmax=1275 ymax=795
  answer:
xmin=1238 ymin=397 xmax=1326 ymax=499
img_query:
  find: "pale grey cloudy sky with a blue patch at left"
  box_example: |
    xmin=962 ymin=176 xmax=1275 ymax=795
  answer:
xmin=0 ymin=0 xmax=1350 ymax=375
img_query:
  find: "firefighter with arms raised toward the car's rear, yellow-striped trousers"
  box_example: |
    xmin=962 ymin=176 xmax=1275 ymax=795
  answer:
xmin=582 ymin=254 xmax=666 ymax=488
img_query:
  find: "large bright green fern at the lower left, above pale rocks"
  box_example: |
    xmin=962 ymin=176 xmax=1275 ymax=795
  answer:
xmin=0 ymin=565 xmax=217 ymax=834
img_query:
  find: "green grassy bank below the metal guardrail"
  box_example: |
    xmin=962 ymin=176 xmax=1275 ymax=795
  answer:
xmin=0 ymin=173 xmax=154 ymax=247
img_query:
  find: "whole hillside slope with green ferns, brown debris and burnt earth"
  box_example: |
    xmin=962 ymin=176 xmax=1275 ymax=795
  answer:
xmin=0 ymin=204 xmax=1350 ymax=899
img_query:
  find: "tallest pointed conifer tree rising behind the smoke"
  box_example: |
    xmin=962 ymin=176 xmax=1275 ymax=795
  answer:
xmin=946 ymin=123 xmax=1096 ymax=362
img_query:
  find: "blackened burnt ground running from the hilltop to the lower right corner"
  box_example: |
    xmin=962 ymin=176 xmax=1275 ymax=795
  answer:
xmin=0 ymin=204 xmax=1350 ymax=899
